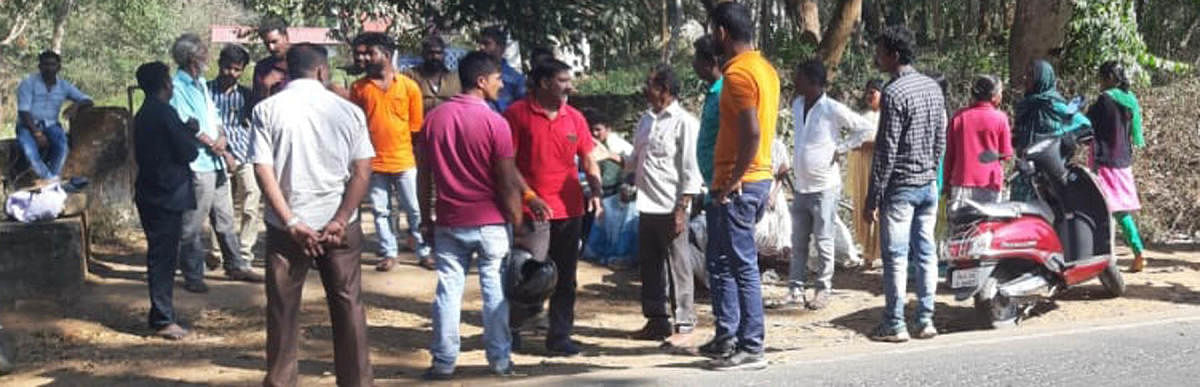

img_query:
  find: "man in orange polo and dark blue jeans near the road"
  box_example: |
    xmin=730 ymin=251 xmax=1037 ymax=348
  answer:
xmin=700 ymin=1 xmax=779 ymax=370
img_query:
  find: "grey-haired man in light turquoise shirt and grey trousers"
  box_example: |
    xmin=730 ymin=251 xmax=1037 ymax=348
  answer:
xmin=170 ymin=34 xmax=263 ymax=293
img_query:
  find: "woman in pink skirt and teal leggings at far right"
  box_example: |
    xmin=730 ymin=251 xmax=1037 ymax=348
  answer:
xmin=1087 ymin=61 xmax=1146 ymax=273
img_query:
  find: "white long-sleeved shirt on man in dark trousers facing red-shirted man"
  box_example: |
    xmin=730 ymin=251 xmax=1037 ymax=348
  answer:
xmin=632 ymin=101 xmax=703 ymax=214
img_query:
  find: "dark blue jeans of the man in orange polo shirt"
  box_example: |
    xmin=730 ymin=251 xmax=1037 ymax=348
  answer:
xmin=704 ymin=180 xmax=770 ymax=353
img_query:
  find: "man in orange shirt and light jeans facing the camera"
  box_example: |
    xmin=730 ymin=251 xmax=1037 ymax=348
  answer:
xmin=350 ymin=32 xmax=433 ymax=272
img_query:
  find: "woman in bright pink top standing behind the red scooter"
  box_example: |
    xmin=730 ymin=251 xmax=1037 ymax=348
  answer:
xmin=946 ymin=76 xmax=1013 ymax=210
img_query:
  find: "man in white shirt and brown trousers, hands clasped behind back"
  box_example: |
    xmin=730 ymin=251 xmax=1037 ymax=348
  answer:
xmin=251 ymin=43 xmax=374 ymax=386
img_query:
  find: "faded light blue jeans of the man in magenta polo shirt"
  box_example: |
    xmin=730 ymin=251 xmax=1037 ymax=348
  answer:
xmin=430 ymin=225 xmax=512 ymax=374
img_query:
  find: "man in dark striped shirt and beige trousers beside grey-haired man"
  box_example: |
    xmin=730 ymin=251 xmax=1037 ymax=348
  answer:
xmin=208 ymin=44 xmax=263 ymax=275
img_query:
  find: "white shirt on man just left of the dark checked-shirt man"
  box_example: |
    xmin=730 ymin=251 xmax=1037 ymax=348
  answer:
xmin=792 ymin=94 xmax=876 ymax=194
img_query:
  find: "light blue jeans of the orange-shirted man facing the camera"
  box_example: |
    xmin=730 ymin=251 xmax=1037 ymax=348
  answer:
xmin=368 ymin=169 xmax=430 ymax=258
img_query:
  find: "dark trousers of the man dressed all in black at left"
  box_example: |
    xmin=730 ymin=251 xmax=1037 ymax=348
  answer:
xmin=137 ymin=203 xmax=184 ymax=329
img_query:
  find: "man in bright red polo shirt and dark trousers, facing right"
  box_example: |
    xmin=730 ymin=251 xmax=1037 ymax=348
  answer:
xmin=504 ymin=60 xmax=601 ymax=356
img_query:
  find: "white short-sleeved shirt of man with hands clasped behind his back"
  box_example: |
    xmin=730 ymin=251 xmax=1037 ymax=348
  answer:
xmin=250 ymin=79 xmax=374 ymax=230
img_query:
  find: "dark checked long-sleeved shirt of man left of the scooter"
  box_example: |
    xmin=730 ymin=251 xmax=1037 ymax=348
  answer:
xmin=866 ymin=67 xmax=947 ymax=210
